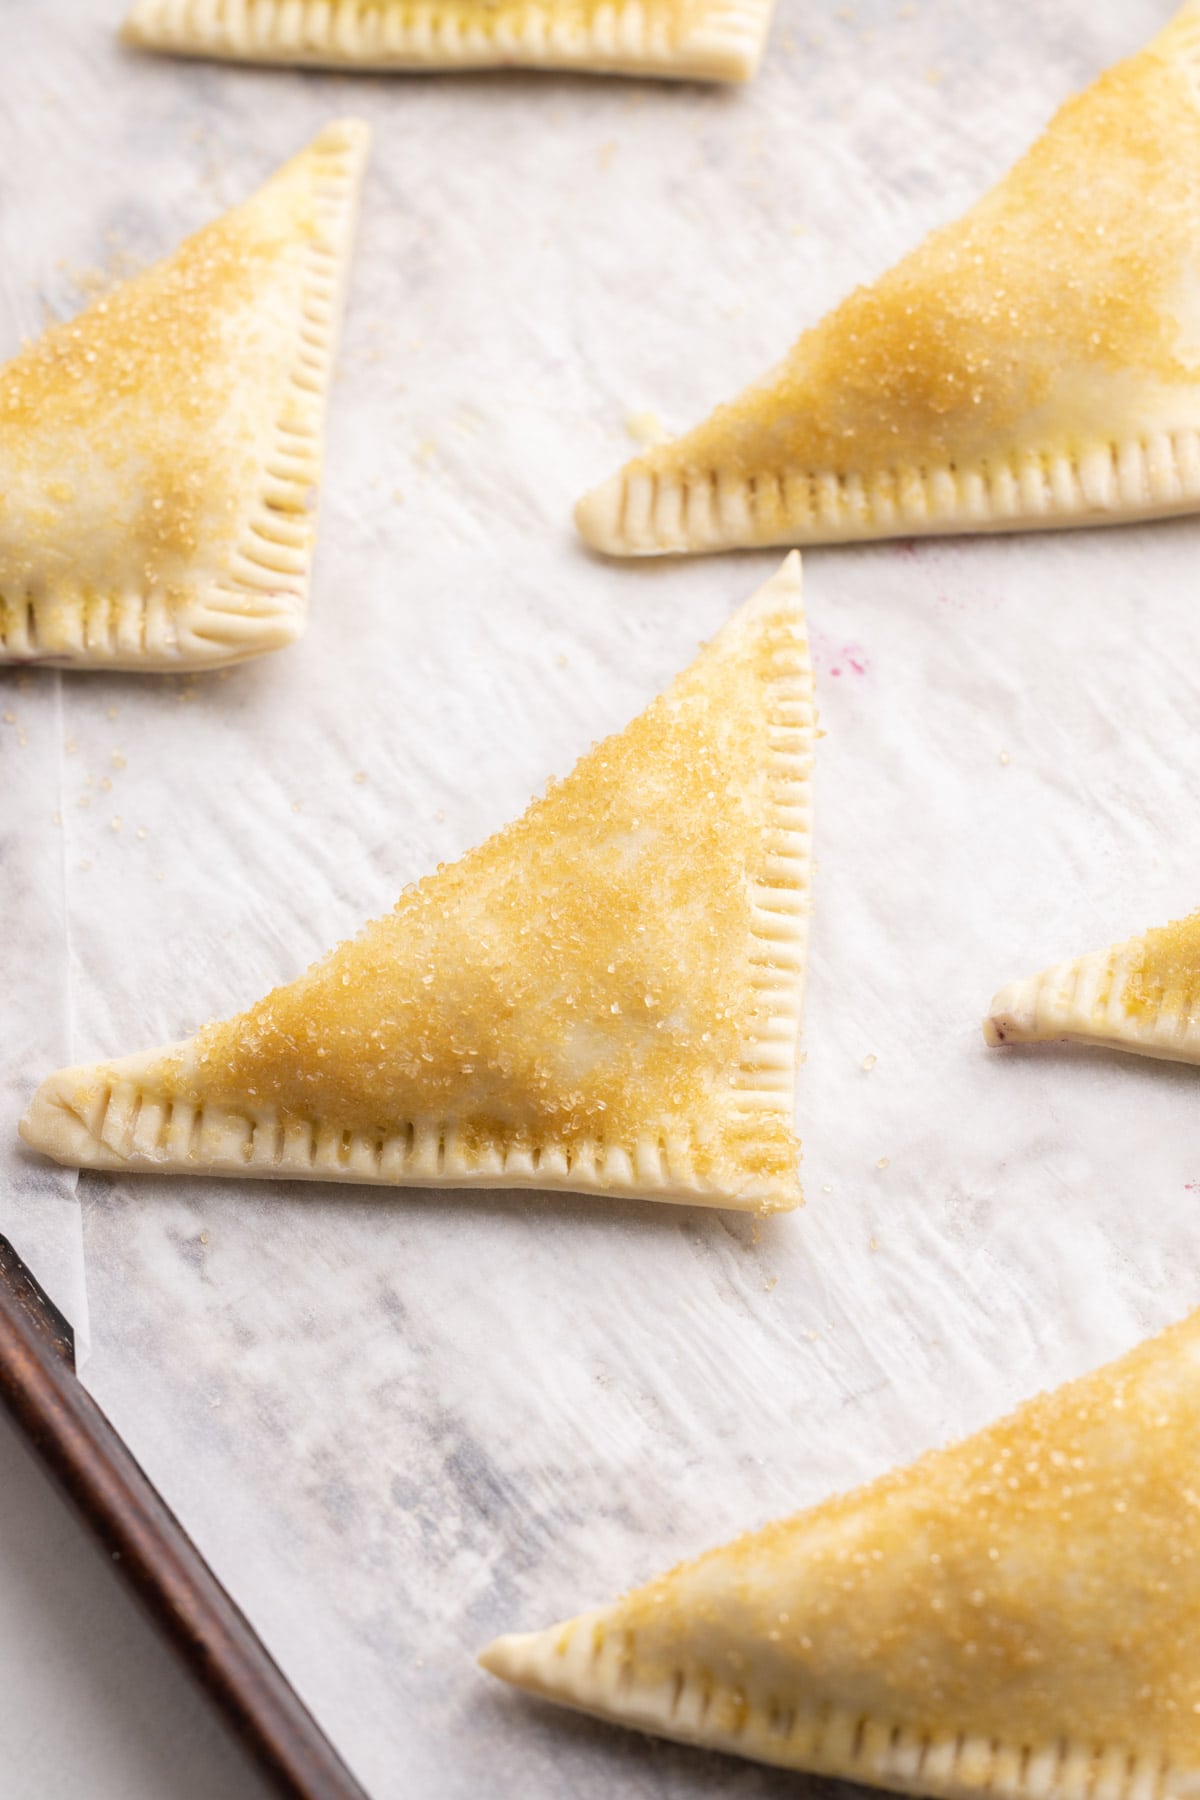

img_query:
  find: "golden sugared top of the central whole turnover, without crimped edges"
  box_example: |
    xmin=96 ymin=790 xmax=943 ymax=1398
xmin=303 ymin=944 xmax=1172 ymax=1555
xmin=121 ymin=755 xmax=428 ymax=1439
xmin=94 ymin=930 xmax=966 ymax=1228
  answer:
xmin=173 ymin=583 xmax=797 ymax=1179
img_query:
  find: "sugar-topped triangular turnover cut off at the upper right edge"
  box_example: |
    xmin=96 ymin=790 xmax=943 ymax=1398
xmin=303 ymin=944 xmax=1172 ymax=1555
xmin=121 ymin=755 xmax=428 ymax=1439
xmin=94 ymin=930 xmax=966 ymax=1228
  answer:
xmin=576 ymin=0 xmax=1200 ymax=556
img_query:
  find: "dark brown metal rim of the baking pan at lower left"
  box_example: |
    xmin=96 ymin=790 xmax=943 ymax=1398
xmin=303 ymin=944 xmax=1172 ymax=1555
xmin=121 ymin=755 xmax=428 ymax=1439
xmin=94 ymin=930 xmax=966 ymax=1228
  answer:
xmin=0 ymin=1237 xmax=367 ymax=1800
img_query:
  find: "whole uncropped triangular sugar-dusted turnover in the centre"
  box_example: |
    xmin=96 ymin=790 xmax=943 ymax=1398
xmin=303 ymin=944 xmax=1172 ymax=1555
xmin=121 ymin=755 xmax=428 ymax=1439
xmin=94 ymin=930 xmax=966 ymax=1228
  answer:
xmin=22 ymin=556 xmax=813 ymax=1211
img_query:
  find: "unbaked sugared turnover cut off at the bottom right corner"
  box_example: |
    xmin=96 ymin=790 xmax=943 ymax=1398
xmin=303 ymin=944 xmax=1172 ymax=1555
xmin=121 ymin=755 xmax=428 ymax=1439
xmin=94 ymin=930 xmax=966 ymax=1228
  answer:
xmin=482 ymin=1314 xmax=1200 ymax=1800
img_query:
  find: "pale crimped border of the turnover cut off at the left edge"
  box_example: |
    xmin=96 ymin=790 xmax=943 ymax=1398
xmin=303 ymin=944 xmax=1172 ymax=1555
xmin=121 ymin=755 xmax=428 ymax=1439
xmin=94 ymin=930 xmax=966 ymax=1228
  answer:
xmin=0 ymin=121 xmax=369 ymax=670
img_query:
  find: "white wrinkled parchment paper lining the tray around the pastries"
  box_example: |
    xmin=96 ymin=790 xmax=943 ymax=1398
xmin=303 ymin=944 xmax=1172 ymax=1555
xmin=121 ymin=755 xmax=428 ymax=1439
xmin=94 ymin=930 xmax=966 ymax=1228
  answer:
xmin=0 ymin=0 xmax=1200 ymax=1800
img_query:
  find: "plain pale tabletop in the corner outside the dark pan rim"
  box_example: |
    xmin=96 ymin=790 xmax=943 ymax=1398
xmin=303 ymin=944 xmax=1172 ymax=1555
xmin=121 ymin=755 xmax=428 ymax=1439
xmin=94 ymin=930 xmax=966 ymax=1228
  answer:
xmin=0 ymin=1413 xmax=268 ymax=1800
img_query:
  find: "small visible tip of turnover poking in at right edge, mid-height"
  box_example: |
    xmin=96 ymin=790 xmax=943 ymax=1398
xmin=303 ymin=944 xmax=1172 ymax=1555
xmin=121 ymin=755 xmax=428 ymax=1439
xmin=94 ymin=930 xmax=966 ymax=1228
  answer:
xmin=984 ymin=913 xmax=1200 ymax=1062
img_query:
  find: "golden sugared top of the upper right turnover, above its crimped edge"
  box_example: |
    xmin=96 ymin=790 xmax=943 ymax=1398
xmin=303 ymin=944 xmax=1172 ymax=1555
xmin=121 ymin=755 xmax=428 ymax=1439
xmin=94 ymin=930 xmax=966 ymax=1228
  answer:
xmin=631 ymin=36 xmax=1200 ymax=493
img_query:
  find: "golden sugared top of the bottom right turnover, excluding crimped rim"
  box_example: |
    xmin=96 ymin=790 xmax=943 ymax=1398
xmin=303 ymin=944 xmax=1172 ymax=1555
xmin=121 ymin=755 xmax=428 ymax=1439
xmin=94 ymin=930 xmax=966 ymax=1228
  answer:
xmin=621 ymin=1318 xmax=1200 ymax=1757
